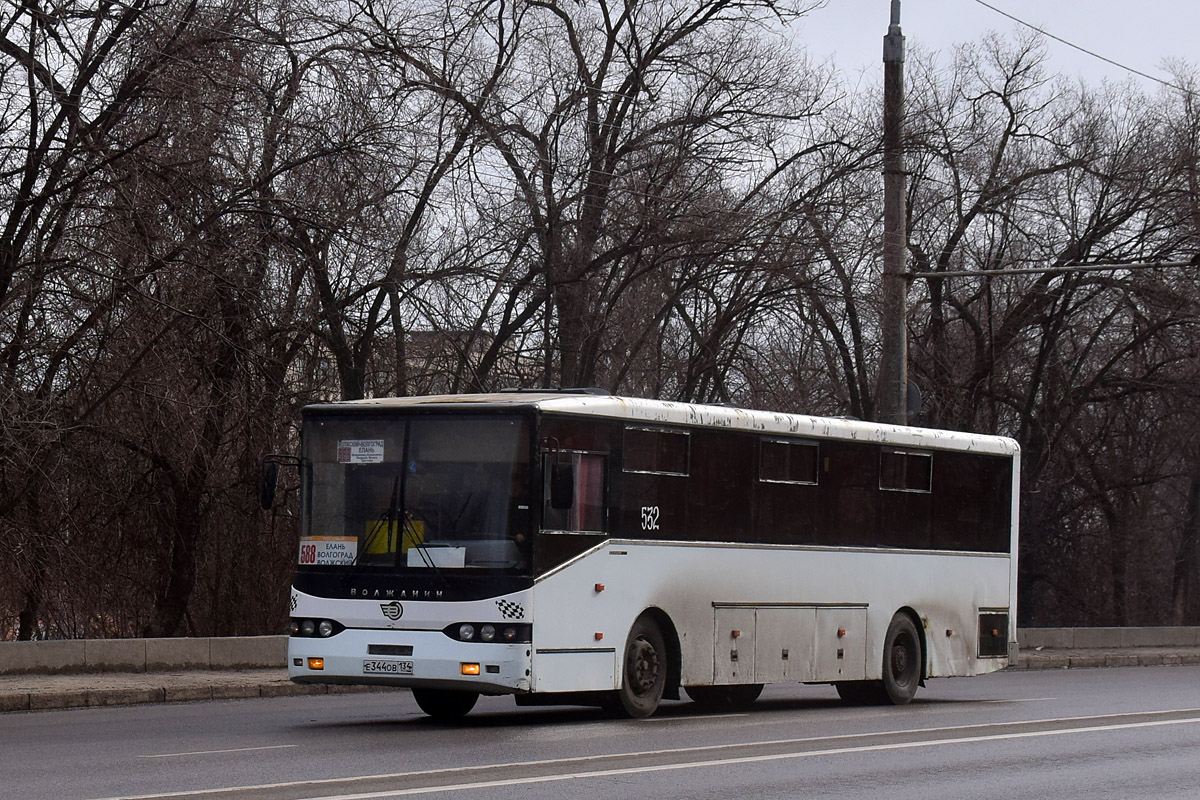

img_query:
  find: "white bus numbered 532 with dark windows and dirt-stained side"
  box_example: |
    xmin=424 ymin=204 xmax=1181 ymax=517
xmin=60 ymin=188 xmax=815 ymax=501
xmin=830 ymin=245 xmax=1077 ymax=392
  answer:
xmin=276 ymin=390 xmax=1020 ymax=718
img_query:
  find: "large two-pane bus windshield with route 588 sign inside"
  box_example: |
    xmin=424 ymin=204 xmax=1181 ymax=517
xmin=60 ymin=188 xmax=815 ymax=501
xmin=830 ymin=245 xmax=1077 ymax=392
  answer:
xmin=299 ymin=415 xmax=530 ymax=571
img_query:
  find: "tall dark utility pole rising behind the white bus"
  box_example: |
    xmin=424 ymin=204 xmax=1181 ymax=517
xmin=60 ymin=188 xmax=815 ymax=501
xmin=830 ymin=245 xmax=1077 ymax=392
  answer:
xmin=876 ymin=0 xmax=908 ymax=425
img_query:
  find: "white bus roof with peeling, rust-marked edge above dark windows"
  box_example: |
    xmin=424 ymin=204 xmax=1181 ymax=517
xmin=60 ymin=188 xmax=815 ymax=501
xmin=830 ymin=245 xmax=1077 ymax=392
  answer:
xmin=304 ymin=390 xmax=1020 ymax=456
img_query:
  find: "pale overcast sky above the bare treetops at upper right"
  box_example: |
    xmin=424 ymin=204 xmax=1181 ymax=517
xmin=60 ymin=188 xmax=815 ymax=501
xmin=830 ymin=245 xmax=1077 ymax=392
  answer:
xmin=798 ymin=0 xmax=1200 ymax=90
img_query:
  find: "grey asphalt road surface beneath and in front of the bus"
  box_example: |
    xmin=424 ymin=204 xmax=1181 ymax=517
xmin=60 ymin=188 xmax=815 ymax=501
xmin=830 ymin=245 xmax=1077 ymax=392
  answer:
xmin=7 ymin=667 xmax=1200 ymax=800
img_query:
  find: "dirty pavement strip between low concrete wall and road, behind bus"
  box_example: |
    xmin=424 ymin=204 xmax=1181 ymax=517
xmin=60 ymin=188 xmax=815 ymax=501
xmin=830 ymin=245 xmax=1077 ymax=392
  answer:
xmin=0 ymin=628 xmax=1200 ymax=711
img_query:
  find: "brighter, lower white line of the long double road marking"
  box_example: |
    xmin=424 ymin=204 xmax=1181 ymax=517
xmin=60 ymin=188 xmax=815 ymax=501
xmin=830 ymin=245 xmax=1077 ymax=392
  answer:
xmin=299 ymin=717 xmax=1200 ymax=800
